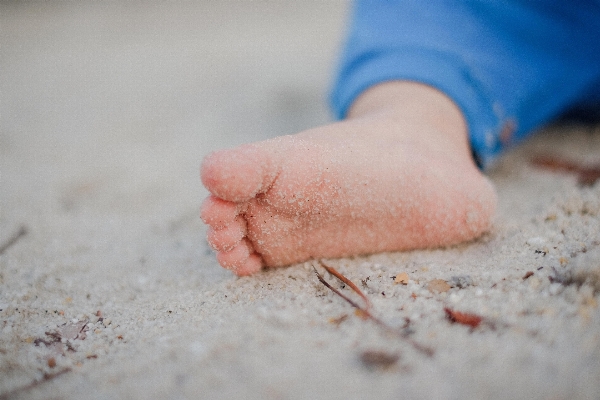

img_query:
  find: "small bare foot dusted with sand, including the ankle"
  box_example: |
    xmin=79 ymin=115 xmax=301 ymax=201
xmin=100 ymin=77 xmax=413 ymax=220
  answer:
xmin=201 ymin=82 xmax=496 ymax=275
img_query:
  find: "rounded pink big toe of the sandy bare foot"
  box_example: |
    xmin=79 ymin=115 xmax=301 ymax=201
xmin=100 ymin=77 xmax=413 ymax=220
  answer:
xmin=200 ymin=145 xmax=277 ymax=202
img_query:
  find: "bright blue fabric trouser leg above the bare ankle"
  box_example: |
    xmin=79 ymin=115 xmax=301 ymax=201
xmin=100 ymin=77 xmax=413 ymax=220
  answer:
xmin=331 ymin=0 xmax=600 ymax=166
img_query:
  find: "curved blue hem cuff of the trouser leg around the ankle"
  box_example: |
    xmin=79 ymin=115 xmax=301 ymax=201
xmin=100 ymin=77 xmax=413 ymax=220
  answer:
xmin=331 ymin=48 xmax=502 ymax=168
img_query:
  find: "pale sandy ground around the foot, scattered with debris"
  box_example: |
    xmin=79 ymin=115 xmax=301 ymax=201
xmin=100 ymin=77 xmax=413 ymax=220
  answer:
xmin=0 ymin=2 xmax=600 ymax=399
